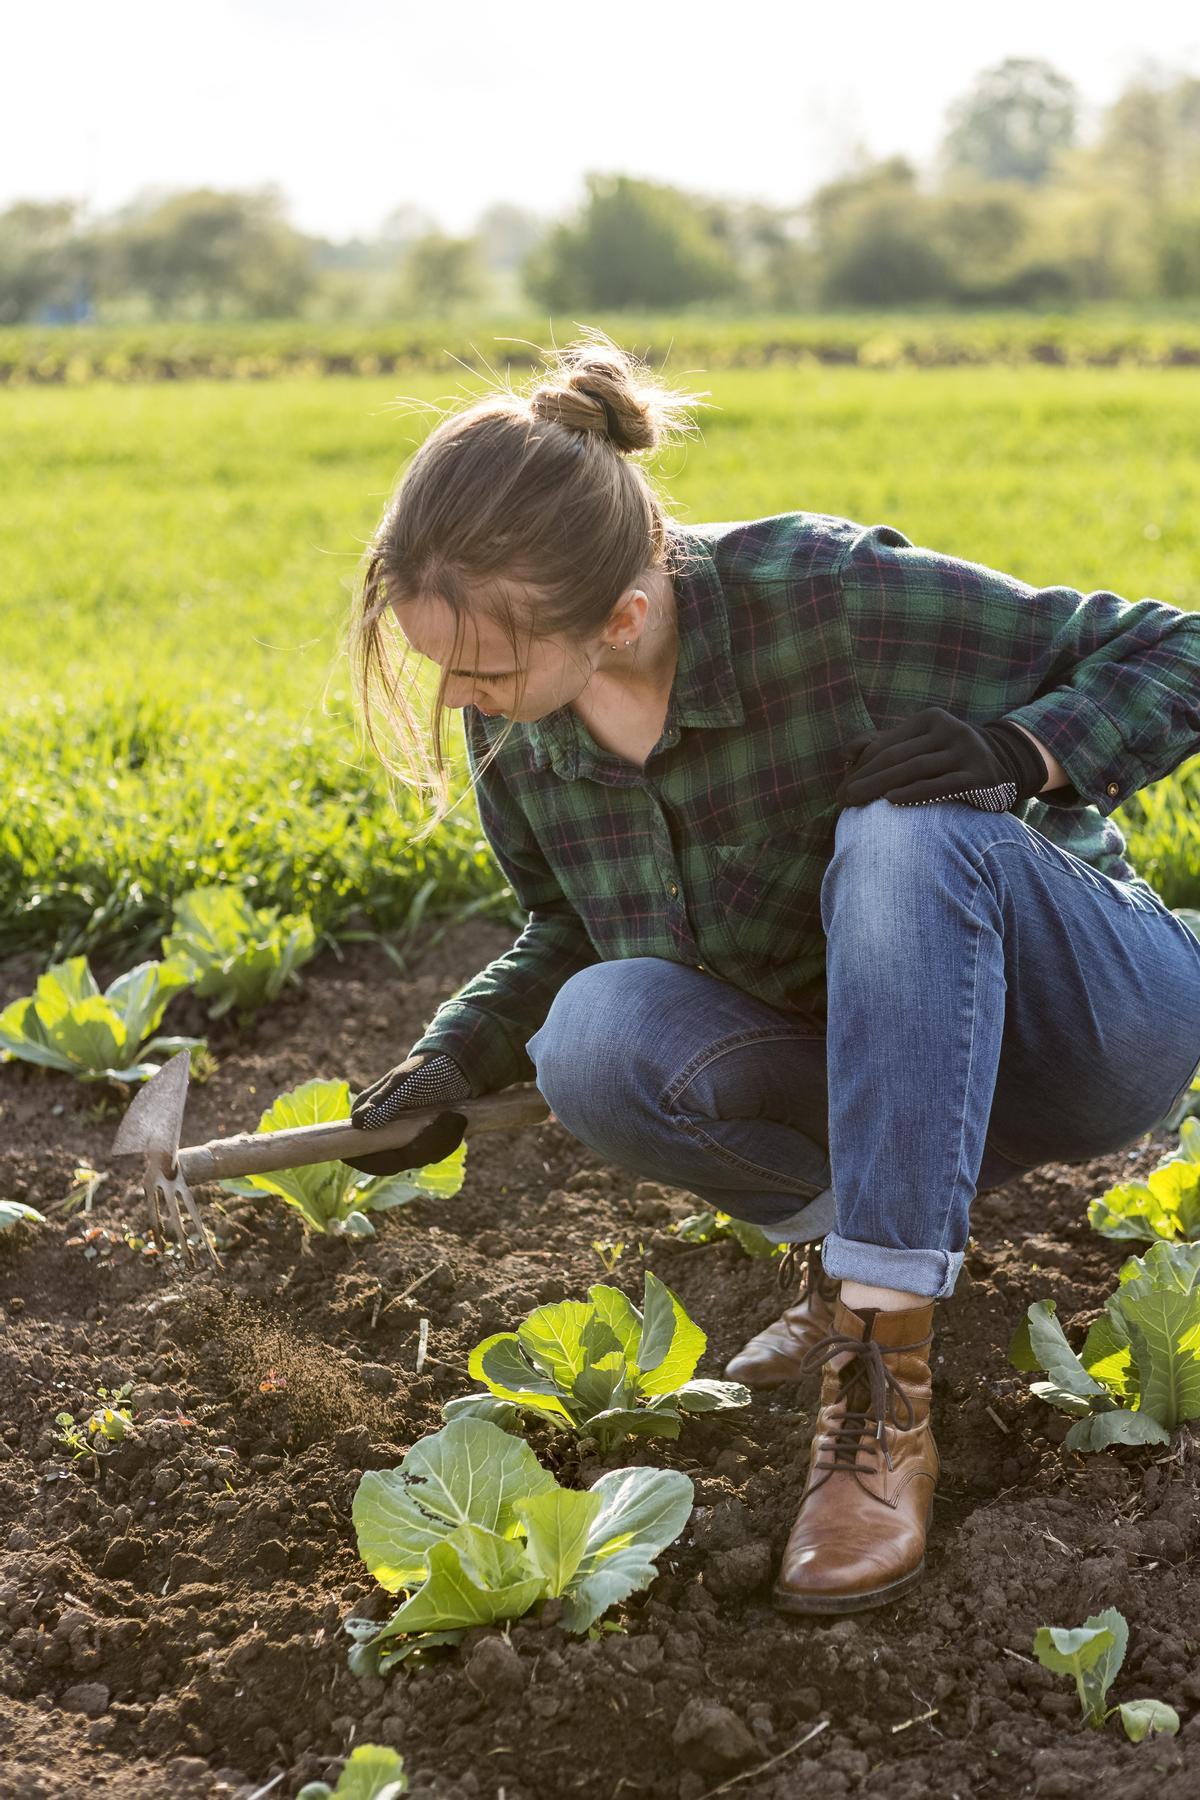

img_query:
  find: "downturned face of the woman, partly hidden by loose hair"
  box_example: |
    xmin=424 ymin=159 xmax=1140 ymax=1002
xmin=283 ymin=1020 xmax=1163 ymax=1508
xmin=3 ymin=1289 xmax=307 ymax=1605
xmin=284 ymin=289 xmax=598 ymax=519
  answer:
xmin=392 ymin=599 xmax=592 ymax=722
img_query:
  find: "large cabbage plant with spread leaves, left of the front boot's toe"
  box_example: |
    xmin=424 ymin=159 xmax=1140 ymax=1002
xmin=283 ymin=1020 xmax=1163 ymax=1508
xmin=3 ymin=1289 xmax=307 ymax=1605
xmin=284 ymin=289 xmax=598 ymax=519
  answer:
xmin=345 ymin=1418 xmax=694 ymax=1674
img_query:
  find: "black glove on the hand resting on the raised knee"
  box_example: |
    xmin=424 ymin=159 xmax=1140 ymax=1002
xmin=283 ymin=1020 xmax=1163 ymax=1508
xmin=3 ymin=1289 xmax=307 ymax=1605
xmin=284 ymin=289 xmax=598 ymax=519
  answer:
xmin=835 ymin=706 xmax=1049 ymax=812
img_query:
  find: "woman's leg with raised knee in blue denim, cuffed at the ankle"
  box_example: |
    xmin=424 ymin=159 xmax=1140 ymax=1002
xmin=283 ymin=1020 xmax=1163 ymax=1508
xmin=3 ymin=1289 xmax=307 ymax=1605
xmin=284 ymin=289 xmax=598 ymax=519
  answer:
xmin=820 ymin=799 xmax=1200 ymax=1300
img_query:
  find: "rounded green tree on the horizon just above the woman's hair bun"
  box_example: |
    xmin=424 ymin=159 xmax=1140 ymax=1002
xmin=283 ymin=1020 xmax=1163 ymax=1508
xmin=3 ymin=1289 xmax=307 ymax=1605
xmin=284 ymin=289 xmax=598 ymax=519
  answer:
xmin=522 ymin=173 xmax=741 ymax=311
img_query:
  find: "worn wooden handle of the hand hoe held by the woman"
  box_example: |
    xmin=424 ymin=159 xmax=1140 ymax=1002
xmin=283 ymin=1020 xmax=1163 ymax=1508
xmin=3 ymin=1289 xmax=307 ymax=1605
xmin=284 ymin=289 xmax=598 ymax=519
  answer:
xmin=178 ymin=1082 xmax=551 ymax=1184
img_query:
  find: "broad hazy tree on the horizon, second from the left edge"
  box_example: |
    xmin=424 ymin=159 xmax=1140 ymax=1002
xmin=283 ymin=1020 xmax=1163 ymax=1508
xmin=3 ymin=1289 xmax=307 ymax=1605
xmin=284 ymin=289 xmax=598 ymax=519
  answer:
xmin=106 ymin=185 xmax=313 ymax=319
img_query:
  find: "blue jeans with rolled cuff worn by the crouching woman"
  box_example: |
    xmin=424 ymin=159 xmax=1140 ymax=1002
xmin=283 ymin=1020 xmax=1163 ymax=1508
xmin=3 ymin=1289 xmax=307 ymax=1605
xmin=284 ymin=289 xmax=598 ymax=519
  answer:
xmin=527 ymin=799 xmax=1200 ymax=1300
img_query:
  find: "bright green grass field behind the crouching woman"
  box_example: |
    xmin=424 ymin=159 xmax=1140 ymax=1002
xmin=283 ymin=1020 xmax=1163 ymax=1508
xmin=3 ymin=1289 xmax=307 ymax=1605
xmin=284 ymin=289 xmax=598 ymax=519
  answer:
xmin=0 ymin=354 xmax=1200 ymax=959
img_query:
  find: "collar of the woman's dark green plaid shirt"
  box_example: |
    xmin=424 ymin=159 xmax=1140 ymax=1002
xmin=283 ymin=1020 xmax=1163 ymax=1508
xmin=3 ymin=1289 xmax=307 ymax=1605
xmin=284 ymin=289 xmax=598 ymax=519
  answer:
xmin=518 ymin=522 xmax=745 ymax=781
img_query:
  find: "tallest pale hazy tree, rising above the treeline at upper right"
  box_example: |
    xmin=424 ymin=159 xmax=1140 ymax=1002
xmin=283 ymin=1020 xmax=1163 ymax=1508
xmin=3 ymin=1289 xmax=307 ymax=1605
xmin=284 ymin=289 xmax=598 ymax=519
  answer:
xmin=941 ymin=56 xmax=1078 ymax=184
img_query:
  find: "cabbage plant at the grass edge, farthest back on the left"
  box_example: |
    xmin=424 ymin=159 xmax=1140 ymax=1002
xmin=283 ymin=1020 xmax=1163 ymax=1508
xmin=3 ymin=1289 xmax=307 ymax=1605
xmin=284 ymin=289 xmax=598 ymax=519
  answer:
xmin=162 ymin=886 xmax=315 ymax=1019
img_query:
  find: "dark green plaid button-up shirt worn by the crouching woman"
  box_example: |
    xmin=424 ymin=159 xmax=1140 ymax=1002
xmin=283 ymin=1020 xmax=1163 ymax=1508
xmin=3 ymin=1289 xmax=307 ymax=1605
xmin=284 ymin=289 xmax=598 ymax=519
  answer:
xmin=412 ymin=511 xmax=1200 ymax=1093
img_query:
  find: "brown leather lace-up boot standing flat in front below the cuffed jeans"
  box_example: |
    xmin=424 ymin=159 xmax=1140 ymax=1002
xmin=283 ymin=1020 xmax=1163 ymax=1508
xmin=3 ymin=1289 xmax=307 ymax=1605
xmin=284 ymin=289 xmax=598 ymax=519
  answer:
xmin=774 ymin=1300 xmax=941 ymax=1613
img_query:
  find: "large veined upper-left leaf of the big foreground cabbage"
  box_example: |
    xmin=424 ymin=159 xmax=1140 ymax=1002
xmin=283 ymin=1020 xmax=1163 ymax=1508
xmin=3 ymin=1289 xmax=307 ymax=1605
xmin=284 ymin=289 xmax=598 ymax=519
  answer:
xmin=351 ymin=1417 xmax=556 ymax=1591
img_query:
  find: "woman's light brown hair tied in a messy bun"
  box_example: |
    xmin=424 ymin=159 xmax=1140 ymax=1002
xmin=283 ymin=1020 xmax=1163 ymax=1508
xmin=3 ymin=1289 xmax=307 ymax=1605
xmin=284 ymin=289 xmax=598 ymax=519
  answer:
xmin=347 ymin=329 xmax=703 ymax=842
